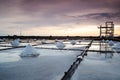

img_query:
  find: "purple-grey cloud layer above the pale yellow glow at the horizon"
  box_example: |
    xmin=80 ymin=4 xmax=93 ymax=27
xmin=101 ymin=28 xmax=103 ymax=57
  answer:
xmin=0 ymin=0 xmax=120 ymax=35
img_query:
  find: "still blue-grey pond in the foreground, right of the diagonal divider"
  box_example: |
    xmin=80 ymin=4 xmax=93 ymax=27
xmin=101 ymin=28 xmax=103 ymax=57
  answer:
xmin=72 ymin=52 xmax=120 ymax=80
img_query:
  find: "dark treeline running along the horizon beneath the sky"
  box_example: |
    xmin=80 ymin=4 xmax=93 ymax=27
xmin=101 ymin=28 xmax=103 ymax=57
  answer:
xmin=0 ymin=35 xmax=120 ymax=41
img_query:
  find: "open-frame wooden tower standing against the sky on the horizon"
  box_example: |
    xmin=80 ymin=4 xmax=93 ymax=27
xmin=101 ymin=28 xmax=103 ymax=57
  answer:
xmin=98 ymin=21 xmax=114 ymax=38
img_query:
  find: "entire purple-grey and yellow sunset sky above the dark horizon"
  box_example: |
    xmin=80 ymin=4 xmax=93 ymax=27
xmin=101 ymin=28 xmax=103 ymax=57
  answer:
xmin=0 ymin=0 xmax=120 ymax=36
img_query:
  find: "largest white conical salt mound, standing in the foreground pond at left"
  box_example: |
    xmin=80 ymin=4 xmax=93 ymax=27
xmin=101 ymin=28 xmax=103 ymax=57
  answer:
xmin=20 ymin=44 xmax=39 ymax=57
